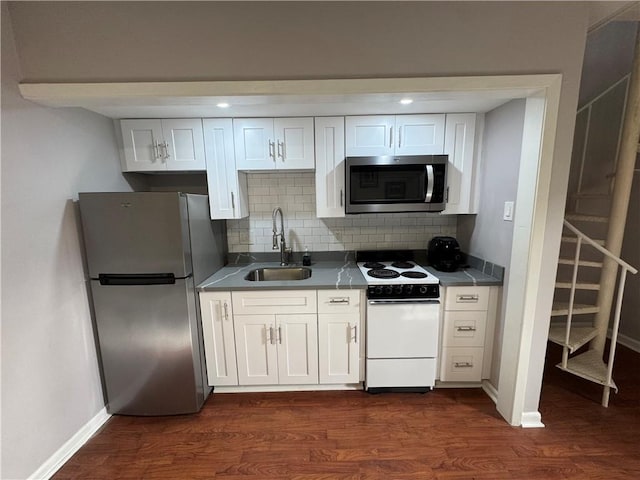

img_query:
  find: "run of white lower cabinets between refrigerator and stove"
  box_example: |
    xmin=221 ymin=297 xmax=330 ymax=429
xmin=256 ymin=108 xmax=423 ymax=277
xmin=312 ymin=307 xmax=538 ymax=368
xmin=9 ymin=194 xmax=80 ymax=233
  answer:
xmin=200 ymin=290 xmax=364 ymax=386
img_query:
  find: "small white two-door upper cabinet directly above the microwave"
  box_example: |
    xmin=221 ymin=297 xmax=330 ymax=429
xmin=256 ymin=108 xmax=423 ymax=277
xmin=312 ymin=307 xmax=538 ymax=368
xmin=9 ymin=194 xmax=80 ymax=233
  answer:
xmin=346 ymin=114 xmax=445 ymax=157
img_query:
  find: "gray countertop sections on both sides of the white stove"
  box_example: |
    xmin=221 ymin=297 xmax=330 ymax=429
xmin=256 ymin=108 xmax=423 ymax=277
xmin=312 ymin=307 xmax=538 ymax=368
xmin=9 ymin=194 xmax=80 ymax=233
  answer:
xmin=198 ymin=261 xmax=503 ymax=292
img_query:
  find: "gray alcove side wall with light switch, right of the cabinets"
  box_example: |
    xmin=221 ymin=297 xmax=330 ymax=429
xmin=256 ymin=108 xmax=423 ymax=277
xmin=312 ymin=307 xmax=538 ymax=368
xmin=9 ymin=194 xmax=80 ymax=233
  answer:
xmin=458 ymin=100 xmax=525 ymax=387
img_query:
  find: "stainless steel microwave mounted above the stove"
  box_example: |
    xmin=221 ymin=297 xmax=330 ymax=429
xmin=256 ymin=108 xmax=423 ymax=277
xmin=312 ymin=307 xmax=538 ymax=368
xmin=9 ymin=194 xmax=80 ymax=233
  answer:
xmin=345 ymin=155 xmax=447 ymax=213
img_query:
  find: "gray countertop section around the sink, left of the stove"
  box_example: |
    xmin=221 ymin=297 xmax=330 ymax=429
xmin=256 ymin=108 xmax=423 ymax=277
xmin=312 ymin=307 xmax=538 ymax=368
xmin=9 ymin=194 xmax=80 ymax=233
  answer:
xmin=197 ymin=261 xmax=367 ymax=292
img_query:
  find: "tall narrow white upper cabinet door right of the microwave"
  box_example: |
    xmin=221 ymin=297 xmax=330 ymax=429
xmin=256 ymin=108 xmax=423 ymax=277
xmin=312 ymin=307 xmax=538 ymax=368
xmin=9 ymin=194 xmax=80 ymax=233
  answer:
xmin=442 ymin=113 xmax=477 ymax=214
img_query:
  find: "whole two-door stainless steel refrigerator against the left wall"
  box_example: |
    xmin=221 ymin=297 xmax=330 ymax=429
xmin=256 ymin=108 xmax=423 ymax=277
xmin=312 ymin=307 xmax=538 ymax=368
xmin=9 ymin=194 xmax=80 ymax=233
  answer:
xmin=79 ymin=192 xmax=227 ymax=415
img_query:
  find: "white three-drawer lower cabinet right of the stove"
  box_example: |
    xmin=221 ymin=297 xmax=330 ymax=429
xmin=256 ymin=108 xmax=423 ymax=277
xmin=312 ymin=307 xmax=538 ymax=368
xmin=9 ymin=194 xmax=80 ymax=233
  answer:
xmin=440 ymin=286 xmax=498 ymax=382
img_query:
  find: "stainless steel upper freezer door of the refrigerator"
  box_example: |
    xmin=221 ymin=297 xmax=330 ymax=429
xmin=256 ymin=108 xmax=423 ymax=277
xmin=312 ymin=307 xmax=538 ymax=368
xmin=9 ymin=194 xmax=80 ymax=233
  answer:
xmin=80 ymin=192 xmax=191 ymax=278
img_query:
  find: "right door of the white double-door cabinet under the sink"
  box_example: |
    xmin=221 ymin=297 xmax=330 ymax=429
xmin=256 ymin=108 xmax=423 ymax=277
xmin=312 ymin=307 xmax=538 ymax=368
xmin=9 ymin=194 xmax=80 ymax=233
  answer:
xmin=276 ymin=314 xmax=318 ymax=385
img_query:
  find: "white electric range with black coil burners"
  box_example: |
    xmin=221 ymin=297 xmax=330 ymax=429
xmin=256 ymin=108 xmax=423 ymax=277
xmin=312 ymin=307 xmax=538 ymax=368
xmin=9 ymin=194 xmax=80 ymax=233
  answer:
xmin=356 ymin=250 xmax=440 ymax=393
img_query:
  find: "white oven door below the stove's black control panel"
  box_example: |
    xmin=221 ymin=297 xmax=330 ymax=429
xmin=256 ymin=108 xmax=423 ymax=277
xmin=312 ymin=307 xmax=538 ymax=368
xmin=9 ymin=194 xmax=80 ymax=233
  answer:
xmin=367 ymin=300 xmax=440 ymax=358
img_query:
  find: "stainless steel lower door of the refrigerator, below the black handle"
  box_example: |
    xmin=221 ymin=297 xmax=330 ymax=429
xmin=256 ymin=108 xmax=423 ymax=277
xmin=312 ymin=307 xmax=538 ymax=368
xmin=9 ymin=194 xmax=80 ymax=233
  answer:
xmin=91 ymin=278 xmax=206 ymax=415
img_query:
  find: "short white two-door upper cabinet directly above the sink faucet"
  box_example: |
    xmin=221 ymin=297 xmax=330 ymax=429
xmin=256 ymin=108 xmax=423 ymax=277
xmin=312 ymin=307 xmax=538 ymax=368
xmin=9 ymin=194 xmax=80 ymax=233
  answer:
xmin=233 ymin=117 xmax=315 ymax=170
